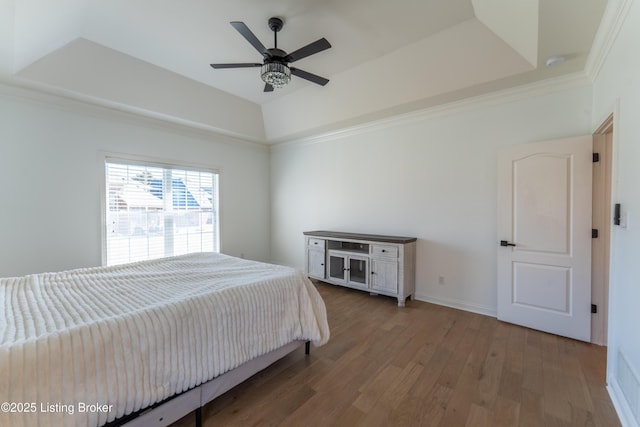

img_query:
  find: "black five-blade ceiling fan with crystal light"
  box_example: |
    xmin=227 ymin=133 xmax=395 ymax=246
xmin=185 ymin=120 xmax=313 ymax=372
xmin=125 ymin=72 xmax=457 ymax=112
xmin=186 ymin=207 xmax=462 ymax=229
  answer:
xmin=211 ymin=18 xmax=331 ymax=92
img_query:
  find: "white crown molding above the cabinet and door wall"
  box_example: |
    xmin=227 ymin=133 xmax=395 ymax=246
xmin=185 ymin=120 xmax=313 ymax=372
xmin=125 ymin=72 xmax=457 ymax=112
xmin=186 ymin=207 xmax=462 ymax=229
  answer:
xmin=270 ymin=72 xmax=592 ymax=151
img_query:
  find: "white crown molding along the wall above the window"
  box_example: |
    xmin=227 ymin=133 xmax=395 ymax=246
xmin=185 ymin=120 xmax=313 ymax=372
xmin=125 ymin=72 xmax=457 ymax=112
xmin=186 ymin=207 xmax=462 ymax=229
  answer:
xmin=0 ymin=75 xmax=268 ymax=150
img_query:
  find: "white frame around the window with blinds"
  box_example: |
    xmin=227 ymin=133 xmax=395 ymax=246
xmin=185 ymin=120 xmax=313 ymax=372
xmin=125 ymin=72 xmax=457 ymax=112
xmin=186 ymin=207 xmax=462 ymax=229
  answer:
xmin=99 ymin=152 xmax=222 ymax=266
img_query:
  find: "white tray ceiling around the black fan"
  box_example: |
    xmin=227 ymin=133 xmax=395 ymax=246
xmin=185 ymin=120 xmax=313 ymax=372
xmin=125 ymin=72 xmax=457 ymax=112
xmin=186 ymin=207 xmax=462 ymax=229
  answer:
xmin=0 ymin=0 xmax=606 ymax=142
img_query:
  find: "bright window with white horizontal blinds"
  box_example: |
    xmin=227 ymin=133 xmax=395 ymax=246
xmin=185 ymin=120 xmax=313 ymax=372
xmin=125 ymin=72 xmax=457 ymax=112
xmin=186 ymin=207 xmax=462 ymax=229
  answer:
xmin=104 ymin=158 xmax=219 ymax=265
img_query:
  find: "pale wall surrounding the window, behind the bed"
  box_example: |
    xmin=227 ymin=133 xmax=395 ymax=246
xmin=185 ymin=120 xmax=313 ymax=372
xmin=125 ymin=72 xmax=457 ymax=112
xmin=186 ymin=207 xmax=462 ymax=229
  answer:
xmin=0 ymin=85 xmax=269 ymax=277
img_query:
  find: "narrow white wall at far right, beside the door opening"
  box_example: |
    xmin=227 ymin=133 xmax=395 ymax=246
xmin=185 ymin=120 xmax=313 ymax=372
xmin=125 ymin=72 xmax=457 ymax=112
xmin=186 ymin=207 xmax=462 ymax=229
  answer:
xmin=593 ymin=1 xmax=640 ymax=425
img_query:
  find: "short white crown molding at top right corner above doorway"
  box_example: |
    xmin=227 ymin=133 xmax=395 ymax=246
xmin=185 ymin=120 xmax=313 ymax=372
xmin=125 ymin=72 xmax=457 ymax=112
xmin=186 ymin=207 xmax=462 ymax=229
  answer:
xmin=584 ymin=0 xmax=633 ymax=82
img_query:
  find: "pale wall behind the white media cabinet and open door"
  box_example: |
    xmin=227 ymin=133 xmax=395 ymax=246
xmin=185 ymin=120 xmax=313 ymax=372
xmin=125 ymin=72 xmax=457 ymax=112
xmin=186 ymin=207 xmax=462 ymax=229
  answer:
xmin=271 ymin=83 xmax=591 ymax=315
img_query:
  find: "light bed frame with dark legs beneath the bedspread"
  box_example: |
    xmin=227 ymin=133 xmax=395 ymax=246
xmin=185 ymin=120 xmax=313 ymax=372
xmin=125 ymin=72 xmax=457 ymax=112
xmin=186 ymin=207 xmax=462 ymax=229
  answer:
xmin=103 ymin=341 xmax=310 ymax=427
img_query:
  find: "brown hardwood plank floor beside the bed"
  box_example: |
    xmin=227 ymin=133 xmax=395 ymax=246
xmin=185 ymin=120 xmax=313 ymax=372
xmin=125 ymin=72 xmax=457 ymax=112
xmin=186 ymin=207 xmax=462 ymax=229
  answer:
xmin=173 ymin=283 xmax=620 ymax=427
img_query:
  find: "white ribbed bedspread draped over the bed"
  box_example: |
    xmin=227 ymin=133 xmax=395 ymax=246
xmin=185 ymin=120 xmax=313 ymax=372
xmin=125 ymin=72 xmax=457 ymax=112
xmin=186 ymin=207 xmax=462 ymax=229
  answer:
xmin=0 ymin=253 xmax=329 ymax=426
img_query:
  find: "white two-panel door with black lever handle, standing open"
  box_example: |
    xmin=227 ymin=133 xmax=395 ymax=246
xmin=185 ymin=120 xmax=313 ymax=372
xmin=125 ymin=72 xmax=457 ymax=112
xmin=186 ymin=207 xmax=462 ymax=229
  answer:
xmin=498 ymin=136 xmax=592 ymax=341
